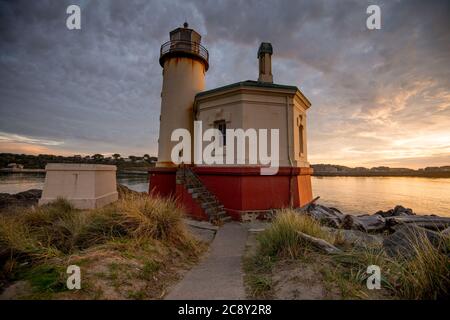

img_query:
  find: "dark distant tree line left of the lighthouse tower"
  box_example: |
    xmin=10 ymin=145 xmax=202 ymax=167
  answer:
xmin=0 ymin=153 xmax=158 ymax=170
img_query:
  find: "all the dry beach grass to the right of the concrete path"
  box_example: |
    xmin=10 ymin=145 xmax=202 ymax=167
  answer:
xmin=245 ymin=210 xmax=450 ymax=299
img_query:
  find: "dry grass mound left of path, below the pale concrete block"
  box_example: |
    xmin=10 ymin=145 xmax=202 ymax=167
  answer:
xmin=0 ymin=194 xmax=204 ymax=297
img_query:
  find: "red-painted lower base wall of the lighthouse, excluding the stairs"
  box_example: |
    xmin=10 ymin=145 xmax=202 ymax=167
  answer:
xmin=149 ymin=167 xmax=313 ymax=220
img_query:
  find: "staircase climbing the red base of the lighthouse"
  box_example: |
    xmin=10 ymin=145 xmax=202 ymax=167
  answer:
xmin=177 ymin=167 xmax=231 ymax=224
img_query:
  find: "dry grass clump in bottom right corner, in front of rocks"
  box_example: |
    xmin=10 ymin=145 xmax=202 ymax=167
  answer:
xmin=328 ymin=232 xmax=450 ymax=299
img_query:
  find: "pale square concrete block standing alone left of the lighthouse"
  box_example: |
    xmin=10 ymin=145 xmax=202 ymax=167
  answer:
xmin=39 ymin=163 xmax=118 ymax=209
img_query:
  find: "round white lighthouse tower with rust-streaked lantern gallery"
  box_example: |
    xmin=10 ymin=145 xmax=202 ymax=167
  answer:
xmin=157 ymin=22 xmax=209 ymax=167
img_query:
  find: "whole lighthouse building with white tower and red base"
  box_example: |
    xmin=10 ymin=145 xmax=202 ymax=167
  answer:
xmin=149 ymin=24 xmax=313 ymax=221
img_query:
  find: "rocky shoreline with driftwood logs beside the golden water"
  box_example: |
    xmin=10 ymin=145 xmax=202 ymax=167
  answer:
xmin=297 ymin=199 xmax=450 ymax=256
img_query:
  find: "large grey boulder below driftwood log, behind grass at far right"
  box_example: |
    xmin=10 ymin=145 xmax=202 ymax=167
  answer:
xmin=383 ymin=225 xmax=443 ymax=257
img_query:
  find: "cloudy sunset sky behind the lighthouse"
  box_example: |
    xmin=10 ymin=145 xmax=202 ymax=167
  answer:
xmin=0 ymin=0 xmax=450 ymax=168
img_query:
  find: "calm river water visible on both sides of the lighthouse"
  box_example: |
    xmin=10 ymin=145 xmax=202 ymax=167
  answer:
xmin=0 ymin=173 xmax=450 ymax=217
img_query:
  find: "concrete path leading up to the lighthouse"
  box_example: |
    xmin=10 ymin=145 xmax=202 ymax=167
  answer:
xmin=165 ymin=222 xmax=248 ymax=300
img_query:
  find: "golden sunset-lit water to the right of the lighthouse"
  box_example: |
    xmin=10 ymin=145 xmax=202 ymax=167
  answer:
xmin=312 ymin=177 xmax=450 ymax=216
